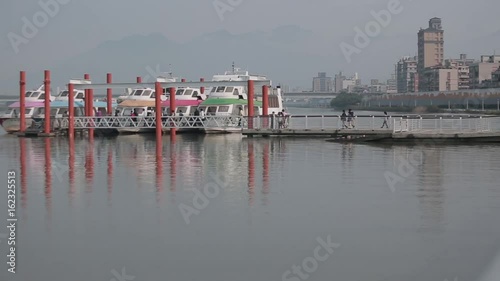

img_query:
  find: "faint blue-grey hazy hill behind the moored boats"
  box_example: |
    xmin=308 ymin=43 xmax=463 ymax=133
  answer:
xmin=0 ymin=26 xmax=333 ymax=93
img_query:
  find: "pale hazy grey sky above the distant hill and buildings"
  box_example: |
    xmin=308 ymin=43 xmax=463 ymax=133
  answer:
xmin=0 ymin=0 xmax=500 ymax=92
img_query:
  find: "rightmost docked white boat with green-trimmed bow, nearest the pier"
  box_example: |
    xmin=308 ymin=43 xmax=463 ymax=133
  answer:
xmin=200 ymin=63 xmax=284 ymax=134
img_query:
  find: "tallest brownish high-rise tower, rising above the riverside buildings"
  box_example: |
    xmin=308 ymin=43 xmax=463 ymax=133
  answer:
xmin=418 ymin=18 xmax=444 ymax=73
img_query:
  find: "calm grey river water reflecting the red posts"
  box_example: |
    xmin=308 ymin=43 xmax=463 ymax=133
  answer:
xmin=0 ymin=107 xmax=500 ymax=281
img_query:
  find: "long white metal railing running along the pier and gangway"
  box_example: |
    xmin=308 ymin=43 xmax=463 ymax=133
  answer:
xmin=47 ymin=115 xmax=500 ymax=133
